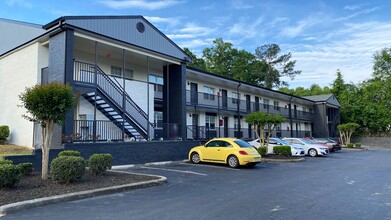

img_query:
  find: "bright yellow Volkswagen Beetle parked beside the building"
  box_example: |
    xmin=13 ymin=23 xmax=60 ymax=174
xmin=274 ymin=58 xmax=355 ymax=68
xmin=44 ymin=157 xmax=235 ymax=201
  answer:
xmin=189 ymin=138 xmax=261 ymax=168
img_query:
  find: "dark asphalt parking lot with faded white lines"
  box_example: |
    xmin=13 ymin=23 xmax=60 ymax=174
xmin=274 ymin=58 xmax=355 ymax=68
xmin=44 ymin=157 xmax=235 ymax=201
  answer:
xmin=4 ymin=148 xmax=391 ymax=220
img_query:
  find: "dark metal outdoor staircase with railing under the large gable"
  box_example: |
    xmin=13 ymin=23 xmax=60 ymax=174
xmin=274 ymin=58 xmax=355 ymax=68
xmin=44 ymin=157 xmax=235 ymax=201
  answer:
xmin=74 ymin=61 xmax=153 ymax=140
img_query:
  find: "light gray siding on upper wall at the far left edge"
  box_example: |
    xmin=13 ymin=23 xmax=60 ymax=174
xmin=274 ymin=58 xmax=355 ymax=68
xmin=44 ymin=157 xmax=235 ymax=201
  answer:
xmin=0 ymin=19 xmax=45 ymax=55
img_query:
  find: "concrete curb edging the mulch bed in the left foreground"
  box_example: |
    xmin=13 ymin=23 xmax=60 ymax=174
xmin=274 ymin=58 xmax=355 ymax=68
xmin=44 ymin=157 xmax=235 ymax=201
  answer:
xmin=0 ymin=171 xmax=167 ymax=217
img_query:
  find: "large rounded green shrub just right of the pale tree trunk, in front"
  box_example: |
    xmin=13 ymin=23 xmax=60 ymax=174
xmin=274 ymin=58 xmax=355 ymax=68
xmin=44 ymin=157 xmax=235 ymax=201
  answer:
xmin=50 ymin=156 xmax=85 ymax=183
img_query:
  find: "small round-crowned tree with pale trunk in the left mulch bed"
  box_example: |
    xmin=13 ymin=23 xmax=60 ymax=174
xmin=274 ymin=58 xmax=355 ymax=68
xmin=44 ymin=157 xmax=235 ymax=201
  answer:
xmin=19 ymin=82 xmax=74 ymax=179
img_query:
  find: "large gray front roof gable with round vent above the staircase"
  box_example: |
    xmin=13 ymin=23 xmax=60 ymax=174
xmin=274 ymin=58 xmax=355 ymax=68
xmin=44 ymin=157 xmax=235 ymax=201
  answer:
xmin=44 ymin=16 xmax=191 ymax=61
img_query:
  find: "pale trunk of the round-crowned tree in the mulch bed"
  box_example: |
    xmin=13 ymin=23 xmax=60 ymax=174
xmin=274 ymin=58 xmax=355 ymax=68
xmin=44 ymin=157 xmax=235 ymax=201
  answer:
xmin=41 ymin=121 xmax=54 ymax=180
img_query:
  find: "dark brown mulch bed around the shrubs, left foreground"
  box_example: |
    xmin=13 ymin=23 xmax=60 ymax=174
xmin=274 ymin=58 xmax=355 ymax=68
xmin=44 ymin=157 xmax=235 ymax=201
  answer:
xmin=0 ymin=171 xmax=158 ymax=206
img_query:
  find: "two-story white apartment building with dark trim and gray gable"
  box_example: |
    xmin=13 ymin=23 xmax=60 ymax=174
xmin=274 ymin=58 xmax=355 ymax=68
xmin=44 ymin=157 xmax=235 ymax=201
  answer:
xmin=0 ymin=16 xmax=339 ymax=150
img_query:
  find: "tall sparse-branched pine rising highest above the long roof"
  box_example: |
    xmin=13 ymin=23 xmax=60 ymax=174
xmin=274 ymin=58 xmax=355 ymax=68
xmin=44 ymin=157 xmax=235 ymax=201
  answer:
xmin=255 ymin=44 xmax=301 ymax=88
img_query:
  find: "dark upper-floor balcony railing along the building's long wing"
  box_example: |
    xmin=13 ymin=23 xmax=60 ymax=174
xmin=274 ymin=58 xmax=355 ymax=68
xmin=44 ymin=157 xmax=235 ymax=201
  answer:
xmin=186 ymin=90 xmax=313 ymax=120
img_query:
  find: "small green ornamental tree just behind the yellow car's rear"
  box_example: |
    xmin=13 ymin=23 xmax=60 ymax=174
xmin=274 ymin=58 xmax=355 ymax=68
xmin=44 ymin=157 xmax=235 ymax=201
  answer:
xmin=245 ymin=112 xmax=285 ymax=152
